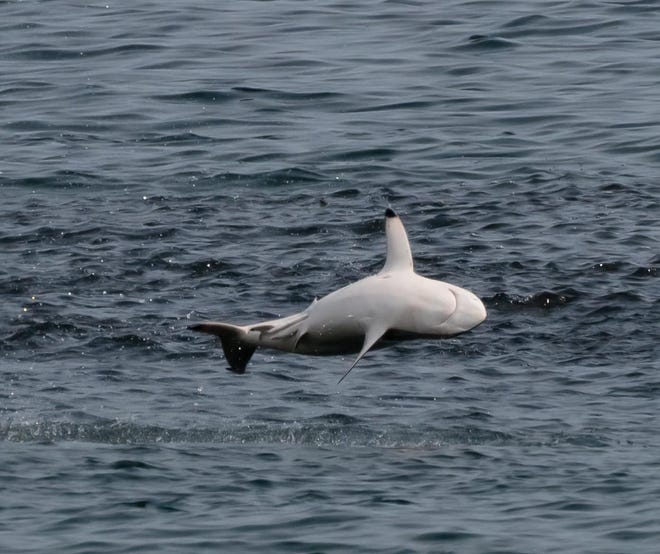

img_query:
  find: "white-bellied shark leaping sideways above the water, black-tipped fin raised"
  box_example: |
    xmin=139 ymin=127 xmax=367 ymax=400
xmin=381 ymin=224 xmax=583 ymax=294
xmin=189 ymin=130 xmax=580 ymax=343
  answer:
xmin=190 ymin=208 xmax=486 ymax=383
